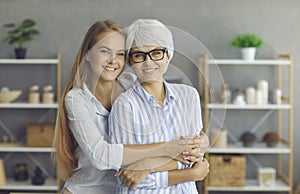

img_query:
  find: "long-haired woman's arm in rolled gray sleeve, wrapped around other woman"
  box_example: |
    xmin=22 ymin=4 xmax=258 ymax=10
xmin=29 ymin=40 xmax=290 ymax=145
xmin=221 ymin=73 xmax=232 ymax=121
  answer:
xmin=65 ymin=89 xmax=199 ymax=170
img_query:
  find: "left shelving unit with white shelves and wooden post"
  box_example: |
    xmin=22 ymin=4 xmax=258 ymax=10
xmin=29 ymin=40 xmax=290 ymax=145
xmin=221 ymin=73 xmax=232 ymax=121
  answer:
xmin=0 ymin=54 xmax=61 ymax=193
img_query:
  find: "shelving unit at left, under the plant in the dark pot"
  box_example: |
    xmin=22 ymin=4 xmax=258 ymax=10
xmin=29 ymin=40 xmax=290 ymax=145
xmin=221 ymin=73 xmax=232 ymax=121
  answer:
xmin=0 ymin=53 xmax=61 ymax=193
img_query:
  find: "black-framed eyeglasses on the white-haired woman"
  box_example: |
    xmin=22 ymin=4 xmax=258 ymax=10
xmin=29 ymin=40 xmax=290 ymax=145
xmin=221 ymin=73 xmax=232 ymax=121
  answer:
xmin=129 ymin=48 xmax=168 ymax=63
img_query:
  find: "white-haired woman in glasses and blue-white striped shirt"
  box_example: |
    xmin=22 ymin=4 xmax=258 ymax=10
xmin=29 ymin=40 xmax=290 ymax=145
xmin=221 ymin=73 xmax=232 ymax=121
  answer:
xmin=109 ymin=19 xmax=209 ymax=194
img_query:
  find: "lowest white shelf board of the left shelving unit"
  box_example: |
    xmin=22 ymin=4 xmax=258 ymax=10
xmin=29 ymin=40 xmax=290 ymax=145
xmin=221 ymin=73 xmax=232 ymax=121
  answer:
xmin=0 ymin=179 xmax=58 ymax=191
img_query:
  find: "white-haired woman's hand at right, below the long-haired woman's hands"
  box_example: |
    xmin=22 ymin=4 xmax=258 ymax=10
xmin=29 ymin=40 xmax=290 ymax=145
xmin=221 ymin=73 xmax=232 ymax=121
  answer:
xmin=188 ymin=158 xmax=209 ymax=181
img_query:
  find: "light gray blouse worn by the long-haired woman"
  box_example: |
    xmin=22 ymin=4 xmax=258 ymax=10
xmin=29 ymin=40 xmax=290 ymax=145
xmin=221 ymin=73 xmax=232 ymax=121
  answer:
xmin=64 ymin=73 xmax=136 ymax=194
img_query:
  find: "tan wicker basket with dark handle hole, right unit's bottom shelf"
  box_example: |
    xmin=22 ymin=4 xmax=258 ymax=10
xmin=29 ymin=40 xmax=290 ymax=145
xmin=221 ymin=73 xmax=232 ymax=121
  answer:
xmin=208 ymin=155 xmax=246 ymax=187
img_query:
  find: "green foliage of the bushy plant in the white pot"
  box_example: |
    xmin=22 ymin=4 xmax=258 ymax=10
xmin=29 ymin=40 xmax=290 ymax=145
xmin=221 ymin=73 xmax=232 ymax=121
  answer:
xmin=230 ymin=33 xmax=263 ymax=48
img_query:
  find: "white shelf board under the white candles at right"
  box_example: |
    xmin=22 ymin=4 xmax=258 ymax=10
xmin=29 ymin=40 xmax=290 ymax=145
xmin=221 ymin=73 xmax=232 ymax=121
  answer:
xmin=207 ymin=104 xmax=291 ymax=110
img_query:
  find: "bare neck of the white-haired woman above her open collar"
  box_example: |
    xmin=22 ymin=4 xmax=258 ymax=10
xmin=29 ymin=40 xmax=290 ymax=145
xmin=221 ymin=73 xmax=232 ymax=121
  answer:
xmin=142 ymin=81 xmax=166 ymax=106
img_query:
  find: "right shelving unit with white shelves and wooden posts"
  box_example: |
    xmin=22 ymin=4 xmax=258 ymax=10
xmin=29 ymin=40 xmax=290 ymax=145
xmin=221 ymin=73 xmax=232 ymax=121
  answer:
xmin=198 ymin=54 xmax=293 ymax=194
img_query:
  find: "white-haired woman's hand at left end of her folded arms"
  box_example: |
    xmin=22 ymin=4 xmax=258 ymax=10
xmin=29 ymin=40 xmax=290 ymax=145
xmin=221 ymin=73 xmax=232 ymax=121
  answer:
xmin=116 ymin=167 xmax=151 ymax=190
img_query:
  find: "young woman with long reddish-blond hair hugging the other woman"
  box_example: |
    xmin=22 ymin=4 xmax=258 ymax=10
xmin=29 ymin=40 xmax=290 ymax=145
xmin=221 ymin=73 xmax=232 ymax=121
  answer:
xmin=54 ymin=20 xmax=206 ymax=194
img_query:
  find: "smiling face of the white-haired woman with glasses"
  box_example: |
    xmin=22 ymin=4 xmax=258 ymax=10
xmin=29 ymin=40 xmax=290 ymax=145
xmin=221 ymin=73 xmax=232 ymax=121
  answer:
xmin=130 ymin=46 xmax=169 ymax=83
